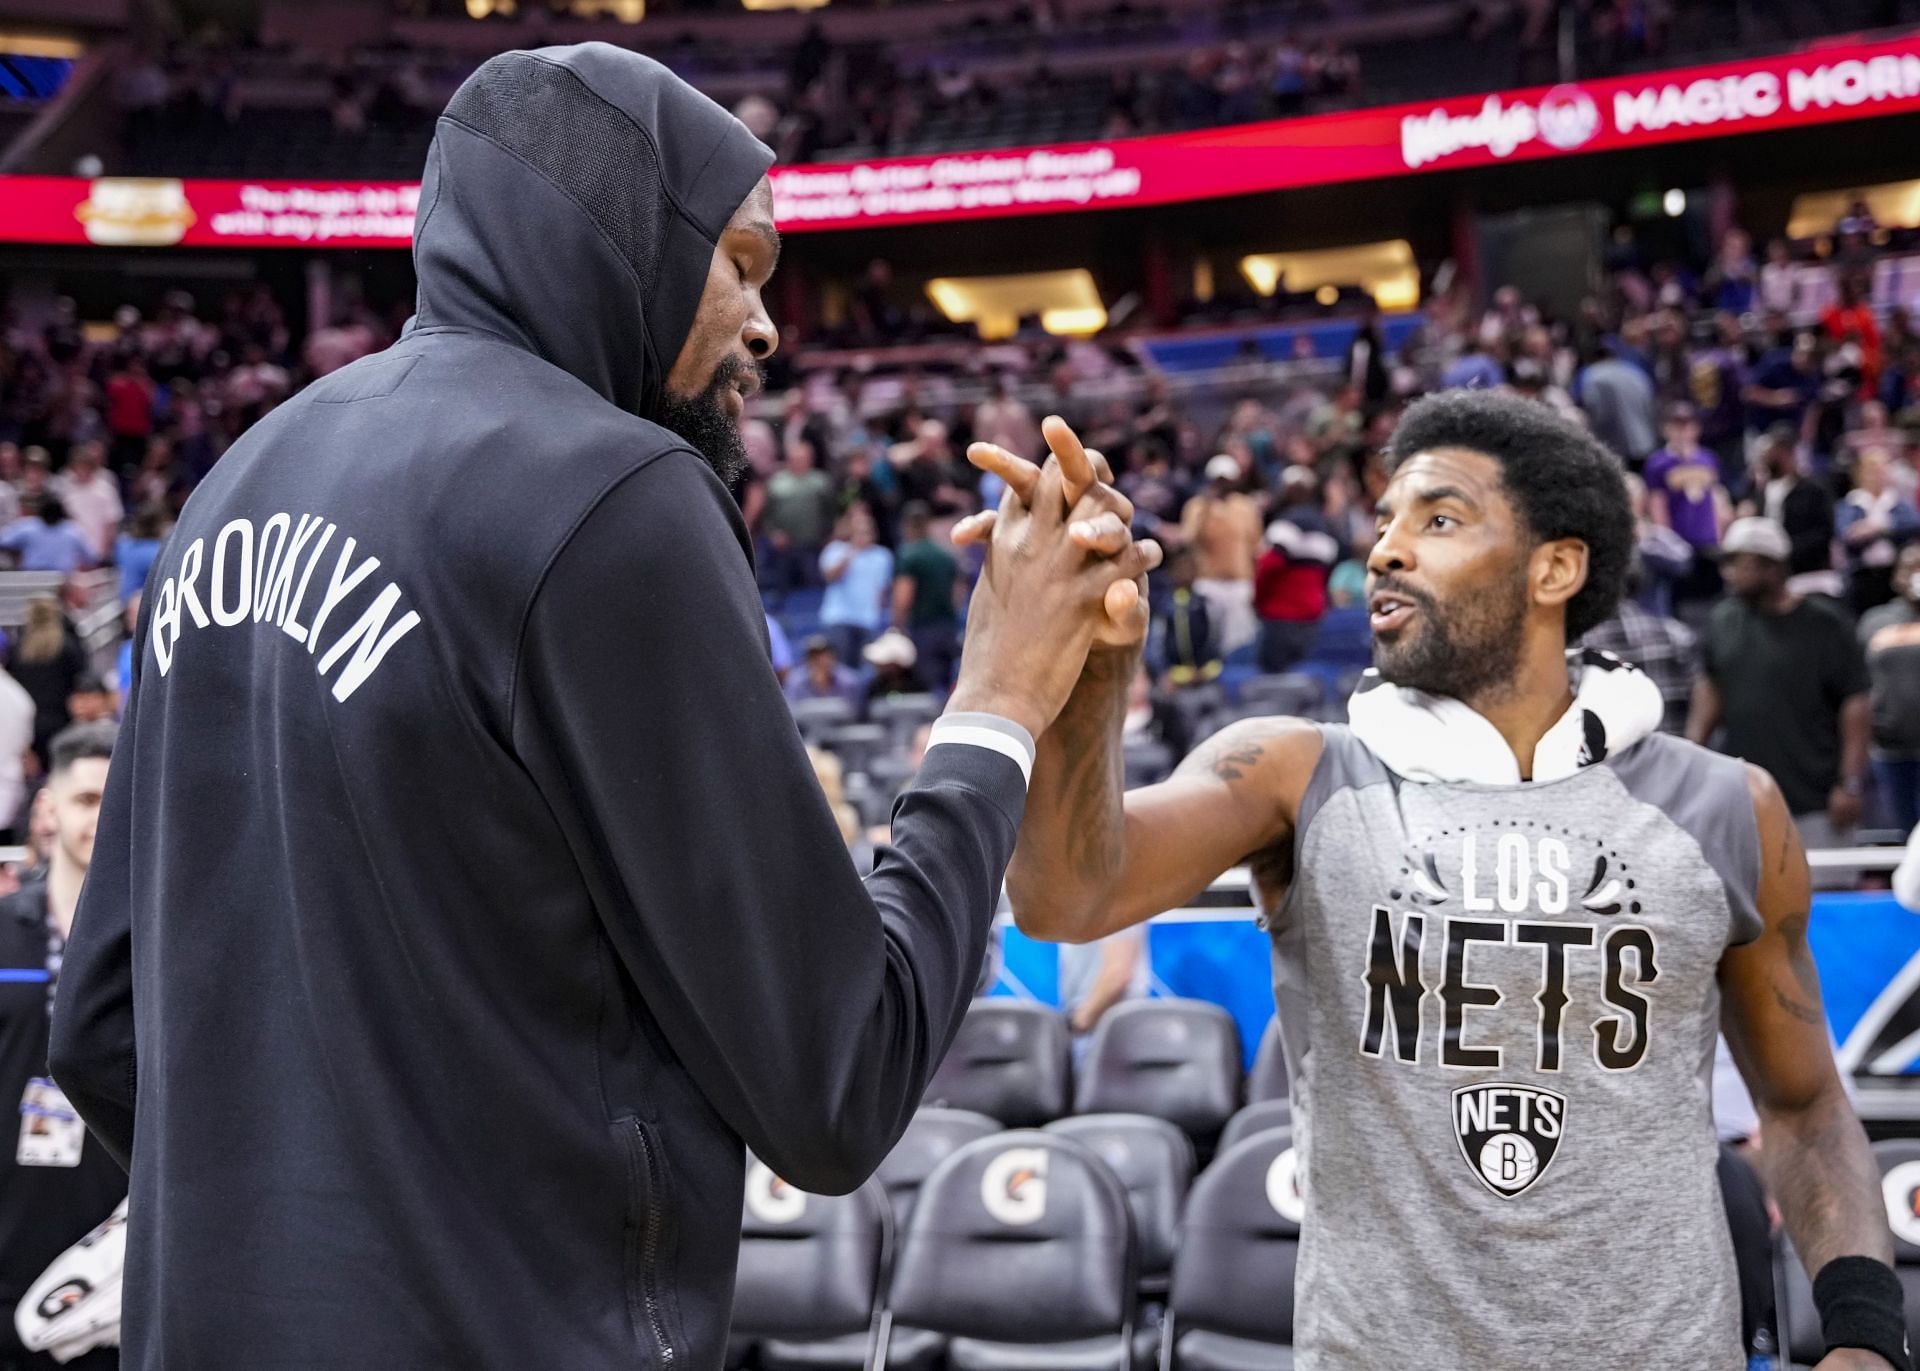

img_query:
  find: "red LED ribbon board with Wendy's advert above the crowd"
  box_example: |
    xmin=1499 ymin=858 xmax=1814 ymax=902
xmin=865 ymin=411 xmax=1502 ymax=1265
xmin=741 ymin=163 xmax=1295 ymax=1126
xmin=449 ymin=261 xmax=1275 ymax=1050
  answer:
xmin=11 ymin=35 xmax=1920 ymax=248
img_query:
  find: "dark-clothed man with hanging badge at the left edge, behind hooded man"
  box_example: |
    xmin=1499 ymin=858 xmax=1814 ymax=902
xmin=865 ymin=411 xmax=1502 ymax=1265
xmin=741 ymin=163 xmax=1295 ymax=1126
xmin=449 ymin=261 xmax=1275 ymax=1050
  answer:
xmin=0 ymin=724 xmax=127 ymax=1371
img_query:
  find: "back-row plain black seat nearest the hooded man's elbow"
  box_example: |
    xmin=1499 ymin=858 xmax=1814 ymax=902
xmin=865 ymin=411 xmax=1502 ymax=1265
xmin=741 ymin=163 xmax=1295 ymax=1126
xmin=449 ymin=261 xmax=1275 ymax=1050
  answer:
xmin=925 ymin=998 xmax=1073 ymax=1127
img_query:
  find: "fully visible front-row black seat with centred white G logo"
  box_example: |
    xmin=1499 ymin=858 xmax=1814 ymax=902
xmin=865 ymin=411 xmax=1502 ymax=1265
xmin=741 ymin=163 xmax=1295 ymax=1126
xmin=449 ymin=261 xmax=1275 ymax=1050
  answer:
xmin=889 ymin=1131 xmax=1152 ymax=1371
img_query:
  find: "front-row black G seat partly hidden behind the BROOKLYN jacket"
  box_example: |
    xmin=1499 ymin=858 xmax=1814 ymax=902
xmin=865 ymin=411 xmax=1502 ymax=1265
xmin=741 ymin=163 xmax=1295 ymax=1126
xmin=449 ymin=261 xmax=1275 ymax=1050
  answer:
xmin=733 ymin=1158 xmax=893 ymax=1340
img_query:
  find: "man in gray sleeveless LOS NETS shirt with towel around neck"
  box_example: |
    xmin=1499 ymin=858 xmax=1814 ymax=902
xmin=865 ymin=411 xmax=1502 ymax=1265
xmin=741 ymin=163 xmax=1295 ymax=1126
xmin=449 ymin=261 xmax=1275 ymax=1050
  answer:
xmin=962 ymin=392 xmax=1908 ymax=1371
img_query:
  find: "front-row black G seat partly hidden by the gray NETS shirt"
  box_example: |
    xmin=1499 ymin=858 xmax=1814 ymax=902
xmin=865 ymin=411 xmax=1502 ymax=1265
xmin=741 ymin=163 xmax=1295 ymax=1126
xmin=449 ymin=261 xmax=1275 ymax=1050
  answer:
xmin=1160 ymin=1129 xmax=1302 ymax=1371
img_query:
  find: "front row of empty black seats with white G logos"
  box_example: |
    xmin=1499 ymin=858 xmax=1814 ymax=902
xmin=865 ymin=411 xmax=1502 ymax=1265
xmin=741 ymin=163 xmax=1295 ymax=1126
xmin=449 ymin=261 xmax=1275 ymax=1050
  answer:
xmin=733 ymin=1110 xmax=1302 ymax=1371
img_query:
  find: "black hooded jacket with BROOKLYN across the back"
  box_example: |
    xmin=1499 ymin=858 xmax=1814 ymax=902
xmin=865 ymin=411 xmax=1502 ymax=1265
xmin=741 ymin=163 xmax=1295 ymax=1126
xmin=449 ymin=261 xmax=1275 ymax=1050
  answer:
xmin=52 ymin=44 xmax=1031 ymax=1371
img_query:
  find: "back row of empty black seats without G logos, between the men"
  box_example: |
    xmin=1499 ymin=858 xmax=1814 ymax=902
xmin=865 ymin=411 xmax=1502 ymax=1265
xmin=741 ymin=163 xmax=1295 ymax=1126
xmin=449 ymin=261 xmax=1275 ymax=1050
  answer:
xmin=927 ymin=998 xmax=1286 ymax=1152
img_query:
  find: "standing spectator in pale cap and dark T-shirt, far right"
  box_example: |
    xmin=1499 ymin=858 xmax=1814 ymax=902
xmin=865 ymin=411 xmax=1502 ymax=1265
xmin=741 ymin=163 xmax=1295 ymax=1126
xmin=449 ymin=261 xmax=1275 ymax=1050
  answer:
xmin=1688 ymin=518 xmax=1872 ymax=887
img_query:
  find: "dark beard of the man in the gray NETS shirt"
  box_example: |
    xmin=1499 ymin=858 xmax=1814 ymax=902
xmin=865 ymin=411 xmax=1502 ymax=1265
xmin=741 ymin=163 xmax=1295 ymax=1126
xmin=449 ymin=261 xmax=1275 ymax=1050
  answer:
xmin=1373 ymin=576 xmax=1526 ymax=703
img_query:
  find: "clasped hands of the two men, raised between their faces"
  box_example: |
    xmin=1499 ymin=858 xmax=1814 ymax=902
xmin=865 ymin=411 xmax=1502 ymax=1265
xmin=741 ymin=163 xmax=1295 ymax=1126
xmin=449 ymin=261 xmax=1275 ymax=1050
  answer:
xmin=948 ymin=419 xmax=1160 ymax=737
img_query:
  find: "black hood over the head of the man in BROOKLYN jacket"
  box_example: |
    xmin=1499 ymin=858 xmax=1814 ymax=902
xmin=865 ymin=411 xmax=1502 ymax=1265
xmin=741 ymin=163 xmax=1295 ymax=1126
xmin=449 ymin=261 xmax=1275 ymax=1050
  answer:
xmin=413 ymin=42 xmax=774 ymax=415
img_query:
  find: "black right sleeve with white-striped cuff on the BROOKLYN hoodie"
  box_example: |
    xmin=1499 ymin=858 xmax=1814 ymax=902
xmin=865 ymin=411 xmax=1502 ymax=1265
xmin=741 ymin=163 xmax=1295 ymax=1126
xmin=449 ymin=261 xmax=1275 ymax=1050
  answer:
xmin=511 ymin=451 xmax=1033 ymax=1192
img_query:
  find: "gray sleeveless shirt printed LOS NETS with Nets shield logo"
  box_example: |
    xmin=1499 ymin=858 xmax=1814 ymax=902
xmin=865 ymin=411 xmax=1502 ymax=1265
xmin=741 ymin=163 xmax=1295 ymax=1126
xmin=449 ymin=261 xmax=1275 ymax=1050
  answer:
xmin=1267 ymin=726 xmax=1761 ymax=1371
